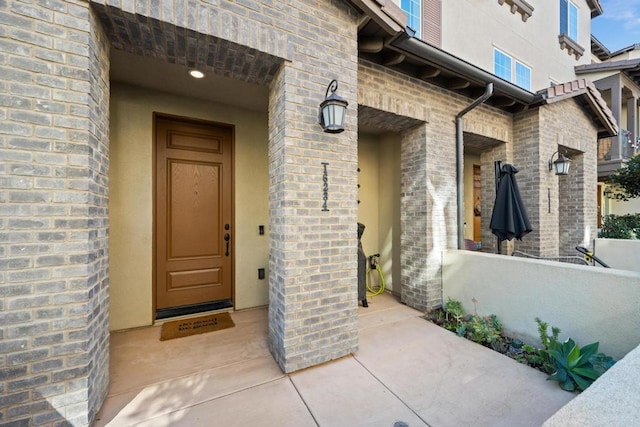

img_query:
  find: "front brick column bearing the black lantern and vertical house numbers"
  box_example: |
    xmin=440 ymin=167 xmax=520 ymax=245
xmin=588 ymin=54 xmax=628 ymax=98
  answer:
xmin=269 ymin=65 xmax=358 ymax=372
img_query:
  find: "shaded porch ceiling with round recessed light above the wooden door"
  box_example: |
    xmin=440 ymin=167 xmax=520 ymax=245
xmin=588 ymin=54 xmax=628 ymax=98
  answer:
xmin=94 ymin=5 xmax=283 ymax=111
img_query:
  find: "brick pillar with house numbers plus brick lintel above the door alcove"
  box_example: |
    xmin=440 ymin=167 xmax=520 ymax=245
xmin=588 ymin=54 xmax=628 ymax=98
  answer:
xmin=90 ymin=0 xmax=358 ymax=372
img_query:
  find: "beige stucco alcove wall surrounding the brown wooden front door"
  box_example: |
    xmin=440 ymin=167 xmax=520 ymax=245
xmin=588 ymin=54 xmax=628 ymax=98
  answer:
xmin=109 ymin=83 xmax=269 ymax=330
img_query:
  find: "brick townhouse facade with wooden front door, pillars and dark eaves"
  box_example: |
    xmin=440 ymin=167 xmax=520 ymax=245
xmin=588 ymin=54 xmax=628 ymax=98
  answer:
xmin=0 ymin=0 xmax=617 ymax=425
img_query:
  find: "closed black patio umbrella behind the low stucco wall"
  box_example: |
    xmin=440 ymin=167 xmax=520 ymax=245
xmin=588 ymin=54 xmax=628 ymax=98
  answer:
xmin=489 ymin=164 xmax=532 ymax=253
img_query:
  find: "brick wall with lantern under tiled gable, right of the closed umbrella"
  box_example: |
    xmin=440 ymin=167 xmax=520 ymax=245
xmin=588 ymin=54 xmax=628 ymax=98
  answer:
xmin=513 ymin=99 xmax=597 ymax=257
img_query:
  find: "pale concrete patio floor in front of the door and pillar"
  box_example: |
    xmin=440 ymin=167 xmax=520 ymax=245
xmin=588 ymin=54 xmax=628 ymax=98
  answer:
xmin=95 ymin=295 xmax=574 ymax=427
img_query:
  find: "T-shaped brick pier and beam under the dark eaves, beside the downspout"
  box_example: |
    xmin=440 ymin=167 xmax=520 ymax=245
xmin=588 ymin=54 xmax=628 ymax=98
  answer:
xmin=358 ymin=59 xmax=512 ymax=310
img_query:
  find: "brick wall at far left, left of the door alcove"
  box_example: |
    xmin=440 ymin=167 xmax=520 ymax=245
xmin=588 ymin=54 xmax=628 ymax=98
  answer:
xmin=0 ymin=1 xmax=109 ymax=425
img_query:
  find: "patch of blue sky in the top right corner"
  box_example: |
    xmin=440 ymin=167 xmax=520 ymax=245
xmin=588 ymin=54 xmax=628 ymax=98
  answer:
xmin=591 ymin=0 xmax=640 ymax=52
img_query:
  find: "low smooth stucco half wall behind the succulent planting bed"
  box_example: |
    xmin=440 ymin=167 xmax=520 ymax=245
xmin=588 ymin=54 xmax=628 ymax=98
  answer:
xmin=442 ymin=250 xmax=640 ymax=359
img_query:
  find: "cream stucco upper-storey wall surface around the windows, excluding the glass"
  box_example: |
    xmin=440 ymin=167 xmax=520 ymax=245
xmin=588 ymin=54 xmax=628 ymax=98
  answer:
xmin=442 ymin=0 xmax=591 ymax=92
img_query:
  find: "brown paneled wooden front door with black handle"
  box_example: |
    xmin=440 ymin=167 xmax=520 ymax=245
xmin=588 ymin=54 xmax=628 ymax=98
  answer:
xmin=155 ymin=116 xmax=233 ymax=318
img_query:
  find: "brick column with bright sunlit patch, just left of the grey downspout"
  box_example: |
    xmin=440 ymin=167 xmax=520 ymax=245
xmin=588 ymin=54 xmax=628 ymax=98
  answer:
xmin=400 ymin=122 xmax=457 ymax=310
